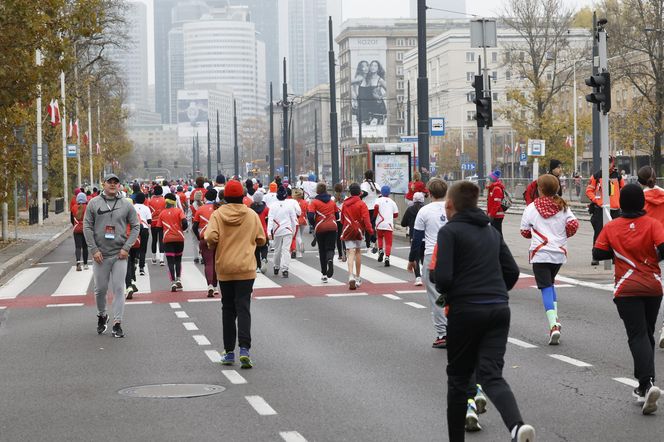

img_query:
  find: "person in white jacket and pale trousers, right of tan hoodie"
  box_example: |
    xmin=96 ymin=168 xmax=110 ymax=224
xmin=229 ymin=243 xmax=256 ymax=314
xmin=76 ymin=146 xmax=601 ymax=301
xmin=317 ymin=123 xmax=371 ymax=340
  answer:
xmin=267 ymin=186 xmax=297 ymax=278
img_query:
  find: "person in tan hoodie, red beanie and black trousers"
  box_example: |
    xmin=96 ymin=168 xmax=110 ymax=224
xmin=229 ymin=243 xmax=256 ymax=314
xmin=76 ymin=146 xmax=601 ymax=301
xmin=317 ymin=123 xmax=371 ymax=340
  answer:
xmin=205 ymin=180 xmax=265 ymax=368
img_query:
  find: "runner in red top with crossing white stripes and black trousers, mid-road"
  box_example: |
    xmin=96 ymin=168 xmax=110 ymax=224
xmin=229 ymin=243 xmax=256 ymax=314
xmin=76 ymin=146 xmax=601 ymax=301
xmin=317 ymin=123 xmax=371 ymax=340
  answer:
xmin=307 ymin=183 xmax=339 ymax=282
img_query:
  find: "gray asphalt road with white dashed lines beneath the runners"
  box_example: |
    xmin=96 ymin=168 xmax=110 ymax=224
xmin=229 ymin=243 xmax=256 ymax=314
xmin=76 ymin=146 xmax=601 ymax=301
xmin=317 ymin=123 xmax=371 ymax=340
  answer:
xmin=0 ymin=226 xmax=664 ymax=441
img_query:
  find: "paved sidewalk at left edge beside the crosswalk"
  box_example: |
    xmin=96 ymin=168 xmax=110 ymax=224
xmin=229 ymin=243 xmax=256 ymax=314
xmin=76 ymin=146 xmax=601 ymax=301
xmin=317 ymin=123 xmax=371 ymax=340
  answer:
xmin=0 ymin=212 xmax=71 ymax=280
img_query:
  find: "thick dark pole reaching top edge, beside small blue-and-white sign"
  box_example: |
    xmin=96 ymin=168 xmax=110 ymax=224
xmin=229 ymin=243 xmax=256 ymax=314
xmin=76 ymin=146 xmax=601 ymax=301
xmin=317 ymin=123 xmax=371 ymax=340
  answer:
xmin=417 ymin=0 xmax=429 ymax=182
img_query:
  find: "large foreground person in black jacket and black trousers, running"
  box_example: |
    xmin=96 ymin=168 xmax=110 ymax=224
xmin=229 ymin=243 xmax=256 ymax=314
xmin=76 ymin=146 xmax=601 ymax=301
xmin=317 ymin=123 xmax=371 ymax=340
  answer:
xmin=435 ymin=181 xmax=535 ymax=442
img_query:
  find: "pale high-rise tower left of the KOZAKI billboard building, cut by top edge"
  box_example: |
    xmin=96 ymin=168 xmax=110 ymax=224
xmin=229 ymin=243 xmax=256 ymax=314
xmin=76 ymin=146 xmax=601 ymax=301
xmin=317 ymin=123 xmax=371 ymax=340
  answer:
xmin=287 ymin=0 xmax=328 ymax=94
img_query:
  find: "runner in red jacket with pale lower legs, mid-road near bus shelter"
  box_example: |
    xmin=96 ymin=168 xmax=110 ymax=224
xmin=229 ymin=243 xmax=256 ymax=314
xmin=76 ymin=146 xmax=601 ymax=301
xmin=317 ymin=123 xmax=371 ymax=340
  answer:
xmin=341 ymin=183 xmax=373 ymax=290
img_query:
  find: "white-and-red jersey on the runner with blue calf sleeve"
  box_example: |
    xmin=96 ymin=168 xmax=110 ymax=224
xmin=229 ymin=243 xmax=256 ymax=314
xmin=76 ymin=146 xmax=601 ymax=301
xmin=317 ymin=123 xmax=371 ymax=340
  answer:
xmin=521 ymin=197 xmax=579 ymax=264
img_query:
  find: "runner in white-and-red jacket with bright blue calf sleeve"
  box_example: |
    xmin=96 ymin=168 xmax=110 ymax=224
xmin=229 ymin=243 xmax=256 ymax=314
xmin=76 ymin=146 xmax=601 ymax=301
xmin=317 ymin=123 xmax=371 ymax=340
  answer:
xmin=521 ymin=175 xmax=579 ymax=345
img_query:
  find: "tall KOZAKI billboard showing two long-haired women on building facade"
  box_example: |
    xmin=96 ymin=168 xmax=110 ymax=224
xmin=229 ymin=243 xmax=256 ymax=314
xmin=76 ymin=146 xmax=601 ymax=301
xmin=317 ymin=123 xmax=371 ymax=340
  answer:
xmin=348 ymin=37 xmax=389 ymax=138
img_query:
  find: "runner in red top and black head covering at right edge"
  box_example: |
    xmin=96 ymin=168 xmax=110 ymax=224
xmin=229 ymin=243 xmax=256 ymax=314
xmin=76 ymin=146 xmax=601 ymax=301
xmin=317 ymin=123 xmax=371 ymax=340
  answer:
xmin=593 ymin=184 xmax=664 ymax=414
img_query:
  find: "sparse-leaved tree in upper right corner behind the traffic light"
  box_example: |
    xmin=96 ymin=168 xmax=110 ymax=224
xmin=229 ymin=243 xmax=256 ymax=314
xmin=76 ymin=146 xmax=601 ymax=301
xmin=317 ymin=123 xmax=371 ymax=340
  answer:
xmin=603 ymin=0 xmax=664 ymax=174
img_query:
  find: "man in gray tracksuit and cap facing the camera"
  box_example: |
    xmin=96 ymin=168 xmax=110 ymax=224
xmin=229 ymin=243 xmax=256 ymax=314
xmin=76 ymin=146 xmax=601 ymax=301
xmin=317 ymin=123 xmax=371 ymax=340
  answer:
xmin=83 ymin=174 xmax=141 ymax=338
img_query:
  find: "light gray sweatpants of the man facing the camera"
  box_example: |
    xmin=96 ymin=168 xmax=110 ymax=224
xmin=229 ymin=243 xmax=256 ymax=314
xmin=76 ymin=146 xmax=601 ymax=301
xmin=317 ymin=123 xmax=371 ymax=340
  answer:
xmin=92 ymin=256 xmax=127 ymax=324
